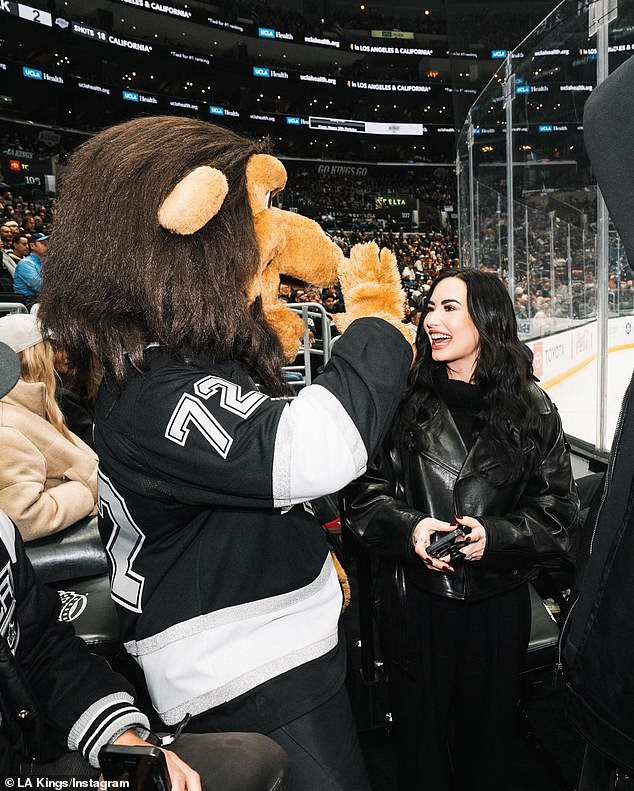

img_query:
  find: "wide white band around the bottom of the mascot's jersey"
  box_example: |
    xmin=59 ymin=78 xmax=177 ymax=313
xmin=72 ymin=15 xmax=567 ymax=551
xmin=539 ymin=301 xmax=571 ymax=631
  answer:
xmin=126 ymin=555 xmax=342 ymax=725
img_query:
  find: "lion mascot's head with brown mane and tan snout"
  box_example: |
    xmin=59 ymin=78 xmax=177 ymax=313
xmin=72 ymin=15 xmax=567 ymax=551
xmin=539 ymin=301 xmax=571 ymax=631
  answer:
xmin=40 ymin=116 xmax=342 ymax=395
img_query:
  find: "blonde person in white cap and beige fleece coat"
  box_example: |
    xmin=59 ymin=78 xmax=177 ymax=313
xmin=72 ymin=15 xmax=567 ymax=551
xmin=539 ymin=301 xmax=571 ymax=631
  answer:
xmin=0 ymin=313 xmax=98 ymax=541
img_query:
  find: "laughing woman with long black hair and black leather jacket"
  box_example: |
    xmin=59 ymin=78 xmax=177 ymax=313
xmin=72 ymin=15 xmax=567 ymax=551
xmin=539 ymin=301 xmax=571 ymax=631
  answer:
xmin=343 ymin=269 xmax=578 ymax=791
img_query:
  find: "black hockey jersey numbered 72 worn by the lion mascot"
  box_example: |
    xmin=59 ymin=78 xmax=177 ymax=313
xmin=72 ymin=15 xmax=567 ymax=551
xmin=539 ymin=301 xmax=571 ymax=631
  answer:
xmin=95 ymin=318 xmax=411 ymax=730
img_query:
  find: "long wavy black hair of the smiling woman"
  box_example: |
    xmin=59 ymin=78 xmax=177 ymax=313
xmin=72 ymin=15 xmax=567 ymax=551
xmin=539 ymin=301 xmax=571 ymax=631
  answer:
xmin=392 ymin=269 xmax=537 ymax=485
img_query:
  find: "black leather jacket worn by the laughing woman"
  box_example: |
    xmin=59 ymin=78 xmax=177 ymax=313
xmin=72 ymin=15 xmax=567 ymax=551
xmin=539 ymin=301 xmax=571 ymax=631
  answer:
xmin=342 ymin=385 xmax=579 ymax=601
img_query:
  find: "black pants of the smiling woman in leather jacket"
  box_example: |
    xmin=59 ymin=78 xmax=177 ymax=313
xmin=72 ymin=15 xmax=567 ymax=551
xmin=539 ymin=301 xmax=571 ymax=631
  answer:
xmin=389 ymin=584 xmax=531 ymax=791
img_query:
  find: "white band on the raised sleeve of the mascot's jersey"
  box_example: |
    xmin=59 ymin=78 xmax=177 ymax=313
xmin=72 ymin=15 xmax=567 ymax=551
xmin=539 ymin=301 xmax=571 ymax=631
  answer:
xmin=272 ymin=384 xmax=368 ymax=508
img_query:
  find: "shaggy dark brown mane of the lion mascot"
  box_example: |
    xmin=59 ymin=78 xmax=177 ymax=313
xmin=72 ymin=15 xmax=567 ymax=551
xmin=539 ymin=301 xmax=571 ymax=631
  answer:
xmin=39 ymin=116 xmax=288 ymax=395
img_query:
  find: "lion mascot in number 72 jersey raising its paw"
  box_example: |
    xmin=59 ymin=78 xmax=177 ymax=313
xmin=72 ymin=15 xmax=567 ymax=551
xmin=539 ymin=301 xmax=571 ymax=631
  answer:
xmin=39 ymin=116 xmax=412 ymax=791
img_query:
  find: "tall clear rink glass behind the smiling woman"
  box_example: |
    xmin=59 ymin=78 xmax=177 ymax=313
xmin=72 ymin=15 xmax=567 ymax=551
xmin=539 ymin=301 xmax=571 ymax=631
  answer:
xmin=457 ymin=0 xmax=634 ymax=452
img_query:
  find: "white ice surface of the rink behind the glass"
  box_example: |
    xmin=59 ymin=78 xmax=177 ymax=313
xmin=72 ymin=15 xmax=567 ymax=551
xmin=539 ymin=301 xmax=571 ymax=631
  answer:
xmin=547 ymin=349 xmax=634 ymax=448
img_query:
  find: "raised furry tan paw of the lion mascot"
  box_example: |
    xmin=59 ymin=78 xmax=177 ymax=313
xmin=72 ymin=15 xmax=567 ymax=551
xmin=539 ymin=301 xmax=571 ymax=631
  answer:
xmin=335 ymin=242 xmax=415 ymax=343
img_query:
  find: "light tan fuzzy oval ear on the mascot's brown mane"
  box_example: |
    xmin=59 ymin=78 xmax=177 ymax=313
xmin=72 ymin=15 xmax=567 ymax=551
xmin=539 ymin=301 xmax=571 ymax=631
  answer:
xmin=158 ymin=165 xmax=229 ymax=236
